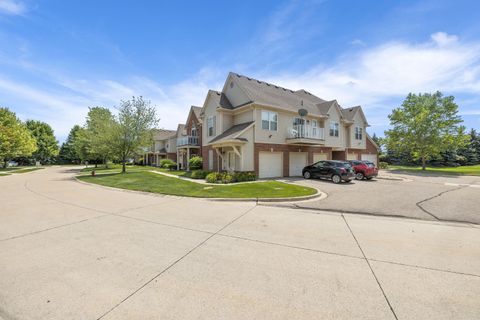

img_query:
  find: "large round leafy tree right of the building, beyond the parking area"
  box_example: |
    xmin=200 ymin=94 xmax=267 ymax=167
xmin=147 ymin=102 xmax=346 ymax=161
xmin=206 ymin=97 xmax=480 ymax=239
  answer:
xmin=385 ymin=91 xmax=466 ymax=170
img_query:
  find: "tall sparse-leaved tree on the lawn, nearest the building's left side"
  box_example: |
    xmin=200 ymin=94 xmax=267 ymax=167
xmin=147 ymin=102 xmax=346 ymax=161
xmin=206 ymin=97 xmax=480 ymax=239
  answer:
xmin=111 ymin=97 xmax=158 ymax=173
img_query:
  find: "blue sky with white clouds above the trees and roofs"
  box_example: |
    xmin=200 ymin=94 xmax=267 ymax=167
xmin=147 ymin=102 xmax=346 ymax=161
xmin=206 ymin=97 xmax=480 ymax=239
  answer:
xmin=0 ymin=0 xmax=480 ymax=141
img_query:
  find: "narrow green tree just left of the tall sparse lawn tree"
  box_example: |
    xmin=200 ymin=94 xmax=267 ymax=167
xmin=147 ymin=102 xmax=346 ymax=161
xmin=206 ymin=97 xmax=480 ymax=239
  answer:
xmin=85 ymin=107 xmax=115 ymax=166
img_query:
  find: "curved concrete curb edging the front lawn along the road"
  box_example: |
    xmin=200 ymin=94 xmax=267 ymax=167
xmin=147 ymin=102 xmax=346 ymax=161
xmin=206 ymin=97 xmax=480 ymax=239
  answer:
xmin=72 ymin=176 xmax=327 ymax=203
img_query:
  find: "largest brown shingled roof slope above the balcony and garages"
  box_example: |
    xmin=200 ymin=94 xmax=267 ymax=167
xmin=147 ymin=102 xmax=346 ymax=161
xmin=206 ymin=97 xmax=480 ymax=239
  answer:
xmin=227 ymin=72 xmax=332 ymax=115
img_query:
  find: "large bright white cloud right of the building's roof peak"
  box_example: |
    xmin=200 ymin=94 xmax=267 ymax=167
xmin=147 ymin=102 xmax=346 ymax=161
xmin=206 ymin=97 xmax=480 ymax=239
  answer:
xmin=265 ymin=33 xmax=480 ymax=109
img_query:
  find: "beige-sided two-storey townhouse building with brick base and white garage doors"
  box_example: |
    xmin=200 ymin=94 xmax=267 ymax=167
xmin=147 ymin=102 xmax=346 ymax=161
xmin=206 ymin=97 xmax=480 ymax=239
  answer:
xmin=144 ymin=73 xmax=378 ymax=178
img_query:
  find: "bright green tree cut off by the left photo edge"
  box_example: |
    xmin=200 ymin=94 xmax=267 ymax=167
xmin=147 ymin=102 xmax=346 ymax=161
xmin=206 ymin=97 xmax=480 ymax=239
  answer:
xmin=0 ymin=108 xmax=37 ymax=167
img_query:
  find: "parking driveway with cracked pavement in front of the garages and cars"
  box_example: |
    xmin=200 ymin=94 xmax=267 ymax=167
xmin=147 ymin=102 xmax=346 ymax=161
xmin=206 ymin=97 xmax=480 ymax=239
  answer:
xmin=288 ymin=171 xmax=480 ymax=224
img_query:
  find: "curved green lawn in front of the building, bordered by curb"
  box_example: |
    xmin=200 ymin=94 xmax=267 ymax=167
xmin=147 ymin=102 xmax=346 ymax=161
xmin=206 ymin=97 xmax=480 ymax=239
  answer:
xmin=79 ymin=170 xmax=317 ymax=198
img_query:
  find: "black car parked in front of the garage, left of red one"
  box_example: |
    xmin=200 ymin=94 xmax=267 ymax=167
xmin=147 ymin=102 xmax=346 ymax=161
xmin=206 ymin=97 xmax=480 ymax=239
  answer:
xmin=302 ymin=160 xmax=355 ymax=183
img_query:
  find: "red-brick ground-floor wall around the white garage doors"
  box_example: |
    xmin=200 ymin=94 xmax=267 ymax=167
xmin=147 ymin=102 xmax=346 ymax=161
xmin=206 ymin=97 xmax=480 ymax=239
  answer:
xmin=253 ymin=143 xmax=332 ymax=177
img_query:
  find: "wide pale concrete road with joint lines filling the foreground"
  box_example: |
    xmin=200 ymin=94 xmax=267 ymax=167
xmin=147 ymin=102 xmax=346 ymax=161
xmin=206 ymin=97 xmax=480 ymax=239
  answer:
xmin=0 ymin=168 xmax=480 ymax=320
